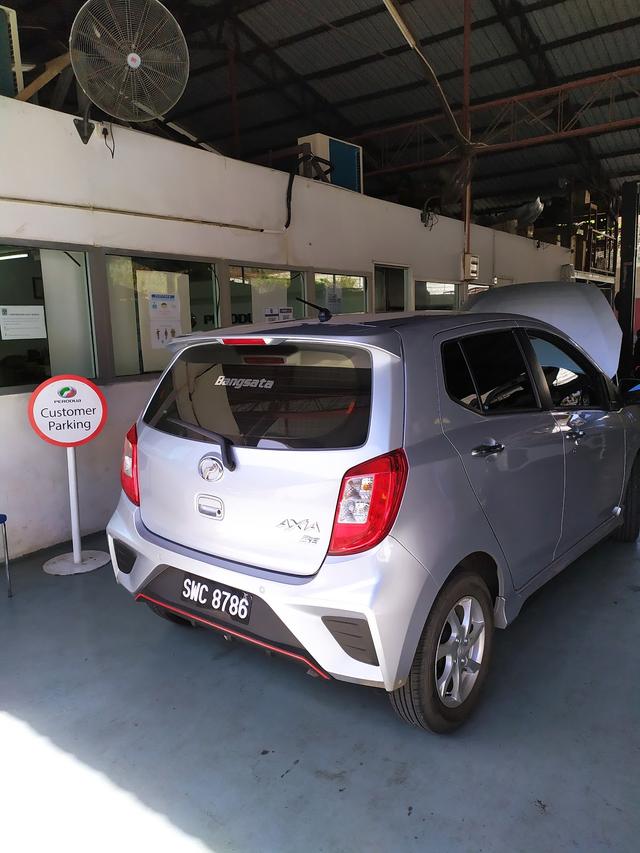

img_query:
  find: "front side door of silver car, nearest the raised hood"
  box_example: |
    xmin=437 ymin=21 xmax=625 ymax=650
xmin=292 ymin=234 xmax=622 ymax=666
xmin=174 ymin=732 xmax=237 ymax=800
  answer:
xmin=527 ymin=329 xmax=625 ymax=555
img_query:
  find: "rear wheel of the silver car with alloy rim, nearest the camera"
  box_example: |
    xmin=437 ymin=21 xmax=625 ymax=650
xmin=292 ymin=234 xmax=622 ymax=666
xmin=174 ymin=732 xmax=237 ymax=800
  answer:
xmin=389 ymin=572 xmax=493 ymax=734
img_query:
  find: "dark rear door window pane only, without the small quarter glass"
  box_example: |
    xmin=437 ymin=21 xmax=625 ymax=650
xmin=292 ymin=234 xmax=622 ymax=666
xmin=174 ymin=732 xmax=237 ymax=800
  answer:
xmin=460 ymin=332 xmax=538 ymax=414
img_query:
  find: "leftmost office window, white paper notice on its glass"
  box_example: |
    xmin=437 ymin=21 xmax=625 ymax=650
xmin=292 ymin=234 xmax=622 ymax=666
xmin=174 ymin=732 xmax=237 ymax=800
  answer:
xmin=0 ymin=240 xmax=95 ymax=388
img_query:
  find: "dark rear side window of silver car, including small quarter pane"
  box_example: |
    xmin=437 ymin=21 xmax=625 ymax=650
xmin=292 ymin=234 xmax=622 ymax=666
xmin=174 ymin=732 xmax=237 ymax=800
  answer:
xmin=443 ymin=331 xmax=539 ymax=415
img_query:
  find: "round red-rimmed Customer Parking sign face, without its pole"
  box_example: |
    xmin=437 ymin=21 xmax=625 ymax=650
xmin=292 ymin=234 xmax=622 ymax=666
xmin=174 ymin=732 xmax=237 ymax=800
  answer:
xmin=28 ymin=373 xmax=107 ymax=447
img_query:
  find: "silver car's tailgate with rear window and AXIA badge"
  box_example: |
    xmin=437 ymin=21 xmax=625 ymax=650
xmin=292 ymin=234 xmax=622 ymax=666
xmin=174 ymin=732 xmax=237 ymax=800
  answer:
xmin=138 ymin=333 xmax=404 ymax=575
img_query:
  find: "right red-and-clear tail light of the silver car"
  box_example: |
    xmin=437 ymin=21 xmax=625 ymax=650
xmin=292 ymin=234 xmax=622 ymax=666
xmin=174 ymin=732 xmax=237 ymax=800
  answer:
xmin=329 ymin=450 xmax=409 ymax=555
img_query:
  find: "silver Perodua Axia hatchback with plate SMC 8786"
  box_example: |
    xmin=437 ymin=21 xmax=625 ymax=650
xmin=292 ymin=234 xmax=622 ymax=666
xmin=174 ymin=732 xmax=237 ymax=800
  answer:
xmin=108 ymin=294 xmax=640 ymax=732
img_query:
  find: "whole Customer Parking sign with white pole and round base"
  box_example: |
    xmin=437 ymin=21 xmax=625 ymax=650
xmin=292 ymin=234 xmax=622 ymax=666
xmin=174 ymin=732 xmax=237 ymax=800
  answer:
xmin=29 ymin=374 xmax=110 ymax=575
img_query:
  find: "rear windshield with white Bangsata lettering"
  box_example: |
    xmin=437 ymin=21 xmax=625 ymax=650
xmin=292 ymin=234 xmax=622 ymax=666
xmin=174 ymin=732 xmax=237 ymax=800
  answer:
xmin=144 ymin=343 xmax=371 ymax=449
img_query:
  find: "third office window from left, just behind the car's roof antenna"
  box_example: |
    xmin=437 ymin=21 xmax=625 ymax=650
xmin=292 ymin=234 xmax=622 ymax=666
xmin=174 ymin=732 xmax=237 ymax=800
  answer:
xmin=229 ymin=266 xmax=305 ymax=326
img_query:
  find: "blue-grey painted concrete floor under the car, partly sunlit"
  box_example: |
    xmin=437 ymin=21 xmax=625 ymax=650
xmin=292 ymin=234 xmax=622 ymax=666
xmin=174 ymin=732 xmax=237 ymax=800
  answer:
xmin=0 ymin=537 xmax=640 ymax=853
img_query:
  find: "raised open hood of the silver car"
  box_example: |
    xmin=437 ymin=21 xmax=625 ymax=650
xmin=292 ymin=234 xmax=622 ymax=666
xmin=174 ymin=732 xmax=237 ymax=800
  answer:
xmin=464 ymin=281 xmax=622 ymax=376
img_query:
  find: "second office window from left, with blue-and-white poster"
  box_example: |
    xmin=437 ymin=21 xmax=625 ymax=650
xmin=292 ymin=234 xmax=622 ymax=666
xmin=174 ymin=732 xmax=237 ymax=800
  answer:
xmin=106 ymin=255 xmax=220 ymax=376
